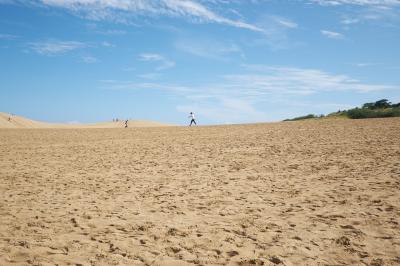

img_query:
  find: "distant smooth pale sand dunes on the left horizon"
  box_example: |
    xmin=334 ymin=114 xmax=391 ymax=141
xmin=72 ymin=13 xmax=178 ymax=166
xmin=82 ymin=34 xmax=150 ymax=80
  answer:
xmin=0 ymin=112 xmax=173 ymax=129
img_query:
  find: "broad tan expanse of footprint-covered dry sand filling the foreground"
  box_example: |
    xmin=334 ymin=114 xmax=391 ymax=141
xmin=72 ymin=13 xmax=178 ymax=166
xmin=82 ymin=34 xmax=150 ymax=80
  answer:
xmin=0 ymin=119 xmax=400 ymax=265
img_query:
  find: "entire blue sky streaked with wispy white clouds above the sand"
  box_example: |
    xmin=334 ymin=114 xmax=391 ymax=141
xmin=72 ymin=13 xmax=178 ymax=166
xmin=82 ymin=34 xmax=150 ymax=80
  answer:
xmin=0 ymin=0 xmax=400 ymax=124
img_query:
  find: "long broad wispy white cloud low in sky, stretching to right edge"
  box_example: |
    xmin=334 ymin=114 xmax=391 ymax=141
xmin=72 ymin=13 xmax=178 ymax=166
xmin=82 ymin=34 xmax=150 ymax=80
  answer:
xmin=103 ymin=65 xmax=400 ymax=95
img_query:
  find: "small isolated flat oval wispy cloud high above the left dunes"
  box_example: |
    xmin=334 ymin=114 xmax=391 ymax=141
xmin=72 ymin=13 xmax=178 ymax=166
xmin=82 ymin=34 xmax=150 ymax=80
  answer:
xmin=28 ymin=40 xmax=87 ymax=56
